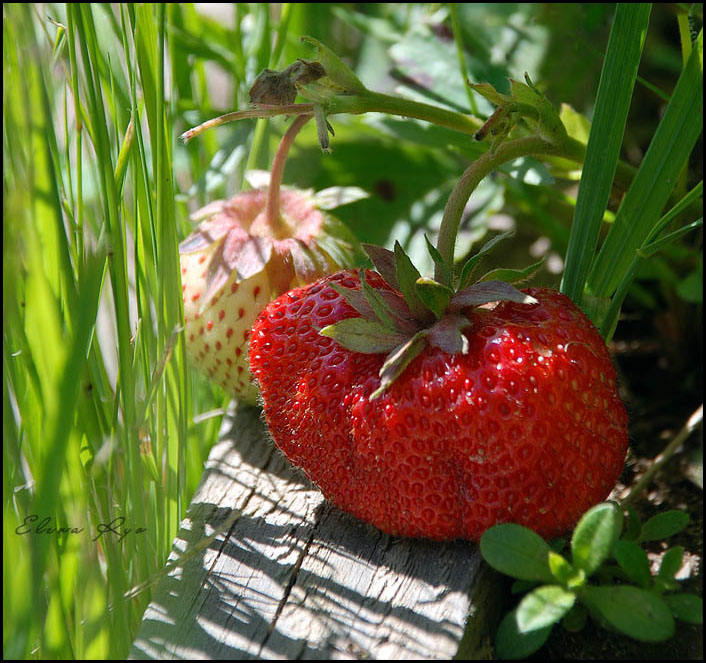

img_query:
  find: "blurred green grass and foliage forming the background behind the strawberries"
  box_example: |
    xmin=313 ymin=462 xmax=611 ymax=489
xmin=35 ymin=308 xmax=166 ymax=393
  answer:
xmin=3 ymin=3 xmax=703 ymax=658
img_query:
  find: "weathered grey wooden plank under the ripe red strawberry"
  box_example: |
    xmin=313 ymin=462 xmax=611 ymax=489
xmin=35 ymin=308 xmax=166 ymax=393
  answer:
xmin=131 ymin=407 xmax=497 ymax=660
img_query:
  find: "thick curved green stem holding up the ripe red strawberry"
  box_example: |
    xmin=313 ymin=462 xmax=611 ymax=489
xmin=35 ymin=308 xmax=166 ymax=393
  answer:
xmin=434 ymin=136 xmax=564 ymax=286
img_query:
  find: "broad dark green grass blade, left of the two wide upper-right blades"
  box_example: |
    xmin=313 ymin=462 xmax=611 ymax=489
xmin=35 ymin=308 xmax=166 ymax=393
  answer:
xmin=561 ymin=3 xmax=651 ymax=303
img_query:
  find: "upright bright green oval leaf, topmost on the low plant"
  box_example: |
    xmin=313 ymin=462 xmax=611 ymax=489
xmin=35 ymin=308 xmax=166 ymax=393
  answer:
xmin=571 ymin=502 xmax=623 ymax=576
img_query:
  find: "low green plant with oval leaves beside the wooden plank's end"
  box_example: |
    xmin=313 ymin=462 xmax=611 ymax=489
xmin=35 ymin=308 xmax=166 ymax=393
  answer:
xmin=480 ymin=502 xmax=703 ymax=658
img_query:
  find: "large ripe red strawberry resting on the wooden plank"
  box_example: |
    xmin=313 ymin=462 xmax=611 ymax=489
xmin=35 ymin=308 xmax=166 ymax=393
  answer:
xmin=250 ymin=268 xmax=627 ymax=540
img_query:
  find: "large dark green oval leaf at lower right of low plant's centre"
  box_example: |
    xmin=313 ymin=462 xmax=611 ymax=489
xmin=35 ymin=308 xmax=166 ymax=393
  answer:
xmin=581 ymin=585 xmax=674 ymax=642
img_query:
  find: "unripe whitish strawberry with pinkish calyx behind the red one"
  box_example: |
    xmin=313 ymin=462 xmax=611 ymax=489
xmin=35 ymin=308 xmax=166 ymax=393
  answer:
xmin=179 ymin=188 xmax=358 ymax=403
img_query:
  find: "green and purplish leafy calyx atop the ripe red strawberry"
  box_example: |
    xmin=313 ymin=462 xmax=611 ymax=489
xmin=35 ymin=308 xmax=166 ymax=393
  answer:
xmin=319 ymin=242 xmax=538 ymax=400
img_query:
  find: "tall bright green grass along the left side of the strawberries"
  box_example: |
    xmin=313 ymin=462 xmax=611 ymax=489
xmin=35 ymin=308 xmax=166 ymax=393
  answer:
xmin=3 ymin=4 xmax=286 ymax=659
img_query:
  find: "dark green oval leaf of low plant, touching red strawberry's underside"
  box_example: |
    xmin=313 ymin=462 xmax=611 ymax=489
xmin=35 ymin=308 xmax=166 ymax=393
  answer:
xmin=480 ymin=523 xmax=554 ymax=583
